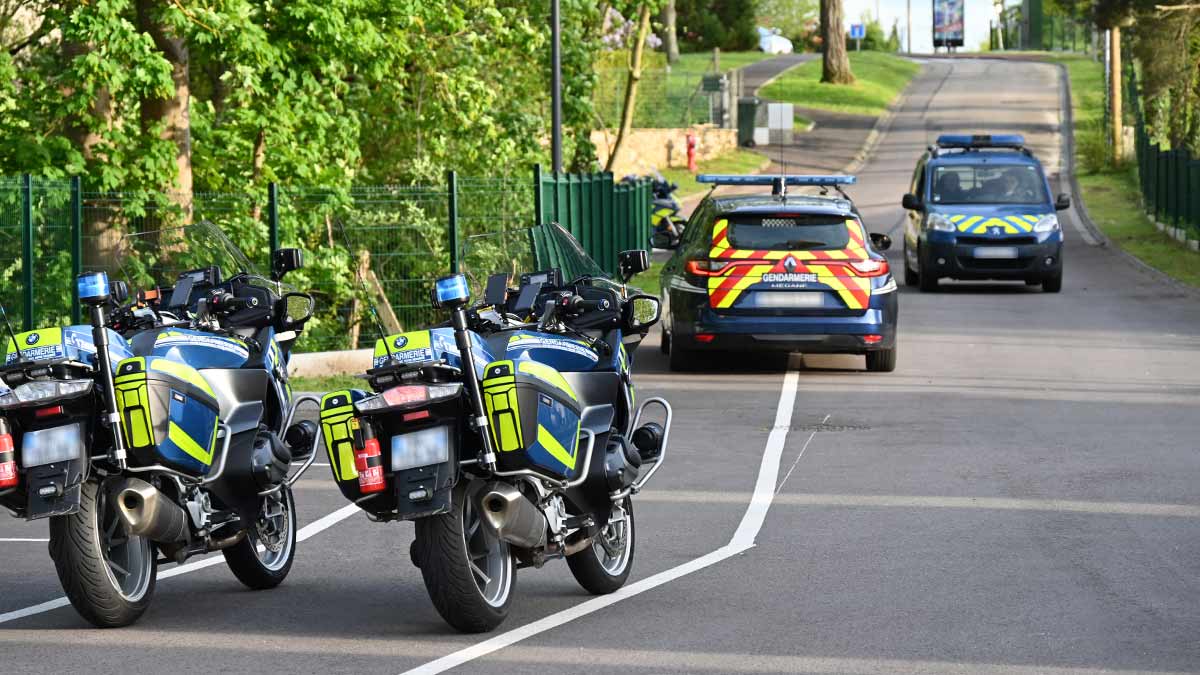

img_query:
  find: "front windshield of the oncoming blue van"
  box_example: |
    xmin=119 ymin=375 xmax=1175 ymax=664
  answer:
xmin=930 ymin=165 xmax=1046 ymax=204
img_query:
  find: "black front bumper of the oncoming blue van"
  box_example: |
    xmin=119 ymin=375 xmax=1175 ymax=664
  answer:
xmin=920 ymin=238 xmax=1062 ymax=281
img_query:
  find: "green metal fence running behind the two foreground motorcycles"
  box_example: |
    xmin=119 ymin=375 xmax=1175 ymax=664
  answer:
xmin=0 ymin=168 xmax=650 ymax=351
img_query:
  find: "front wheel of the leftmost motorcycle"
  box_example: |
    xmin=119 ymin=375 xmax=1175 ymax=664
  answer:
xmin=221 ymin=485 xmax=296 ymax=591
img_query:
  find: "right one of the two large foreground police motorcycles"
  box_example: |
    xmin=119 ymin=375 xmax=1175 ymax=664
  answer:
xmin=320 ymin=225 xmax=671 ymax=633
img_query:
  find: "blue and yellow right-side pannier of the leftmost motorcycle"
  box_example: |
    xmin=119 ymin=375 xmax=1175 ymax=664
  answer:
xmin=114 ymin=357 xmax=221 ymax=476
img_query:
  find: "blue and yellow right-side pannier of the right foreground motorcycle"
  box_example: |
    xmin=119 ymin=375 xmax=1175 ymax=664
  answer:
xmin=482 ymin=360 xmax=586 ymax=479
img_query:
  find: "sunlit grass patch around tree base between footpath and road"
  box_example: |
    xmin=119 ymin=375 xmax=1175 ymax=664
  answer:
xmin=760 ymin=52 xmax=920 ymax=115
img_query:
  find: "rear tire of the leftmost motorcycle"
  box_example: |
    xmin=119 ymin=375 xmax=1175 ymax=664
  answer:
xmin=49 ymin=479 xmax=158 ymax=628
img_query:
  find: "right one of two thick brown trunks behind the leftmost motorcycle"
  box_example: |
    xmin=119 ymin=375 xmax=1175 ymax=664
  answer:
xmin=137 ymin=0 xmax=192 ymax=222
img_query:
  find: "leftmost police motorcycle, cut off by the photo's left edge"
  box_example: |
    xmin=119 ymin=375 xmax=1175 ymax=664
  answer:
xmin=0 ymin=222 xmax=318 ymax=627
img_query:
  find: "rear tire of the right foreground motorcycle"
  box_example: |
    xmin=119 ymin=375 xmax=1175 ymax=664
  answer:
xmin=413 ymin=482 xmax=517 ymax=633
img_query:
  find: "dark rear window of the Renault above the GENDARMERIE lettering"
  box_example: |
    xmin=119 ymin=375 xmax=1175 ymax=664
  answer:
xmin=728 ymin=214 xmax=850 ymax=251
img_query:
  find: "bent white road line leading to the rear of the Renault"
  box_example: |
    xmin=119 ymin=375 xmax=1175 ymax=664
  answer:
xmin=404 ymin=370 xmax=799 ymax=675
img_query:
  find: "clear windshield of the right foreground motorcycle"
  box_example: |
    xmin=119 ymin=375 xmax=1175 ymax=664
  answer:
xmin=461 ymin=223 xmax=610 ymax=292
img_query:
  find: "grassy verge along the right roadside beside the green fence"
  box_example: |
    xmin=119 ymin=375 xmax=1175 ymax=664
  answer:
xmin=1045 ymin=54 xmax=1200 ymax=287
